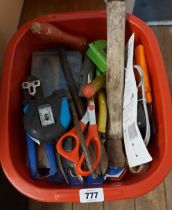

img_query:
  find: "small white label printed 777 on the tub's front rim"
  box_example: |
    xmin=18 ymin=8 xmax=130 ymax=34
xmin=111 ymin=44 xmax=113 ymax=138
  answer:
xmin=79 ymin=188 xmax=104 ymax=203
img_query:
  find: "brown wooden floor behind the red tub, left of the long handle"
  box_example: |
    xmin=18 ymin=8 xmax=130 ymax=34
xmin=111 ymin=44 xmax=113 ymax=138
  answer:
xmin=20 ymin=0 xmax=106 ymax=25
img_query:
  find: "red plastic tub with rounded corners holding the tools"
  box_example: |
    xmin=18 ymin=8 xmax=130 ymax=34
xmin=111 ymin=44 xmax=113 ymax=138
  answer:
xmin=0 ymin=11 xmax=172 ymax=202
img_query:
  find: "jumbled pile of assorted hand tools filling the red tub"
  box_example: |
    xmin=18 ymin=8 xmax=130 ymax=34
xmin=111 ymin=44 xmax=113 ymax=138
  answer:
xmin=22 ymin=13 xmax=155 ymax=185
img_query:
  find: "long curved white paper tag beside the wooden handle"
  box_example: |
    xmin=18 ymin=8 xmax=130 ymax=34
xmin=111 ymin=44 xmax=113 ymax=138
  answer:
xmin=123 ymin=34 xmax=152 ymax=167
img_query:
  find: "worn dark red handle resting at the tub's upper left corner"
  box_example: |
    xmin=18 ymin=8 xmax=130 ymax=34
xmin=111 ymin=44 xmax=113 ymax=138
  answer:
xmin=31 ymin=22 xmax=87 ymax=51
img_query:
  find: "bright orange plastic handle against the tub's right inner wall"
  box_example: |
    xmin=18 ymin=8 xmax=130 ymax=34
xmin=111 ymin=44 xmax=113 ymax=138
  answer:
xmin=135 ymin=45 xmax=152 ymax=103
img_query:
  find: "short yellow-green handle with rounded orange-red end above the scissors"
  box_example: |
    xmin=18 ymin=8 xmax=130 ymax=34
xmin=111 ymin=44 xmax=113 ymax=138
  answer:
xmin=82 ymin=74 xmax=106 ymax=99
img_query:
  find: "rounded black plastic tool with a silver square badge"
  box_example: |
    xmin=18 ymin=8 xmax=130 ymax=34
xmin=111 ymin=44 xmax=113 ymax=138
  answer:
xmin=24 ymin=90 xmax=66 ymax=144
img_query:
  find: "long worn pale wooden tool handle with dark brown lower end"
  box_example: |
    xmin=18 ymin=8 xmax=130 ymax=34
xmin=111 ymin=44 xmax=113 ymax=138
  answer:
xmin=106 ymin=0 xmax=126 ymax=167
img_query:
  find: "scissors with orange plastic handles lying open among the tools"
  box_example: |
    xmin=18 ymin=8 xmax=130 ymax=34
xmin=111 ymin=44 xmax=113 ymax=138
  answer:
xmin=56 ymin=99 xmax=101 ymax=176
